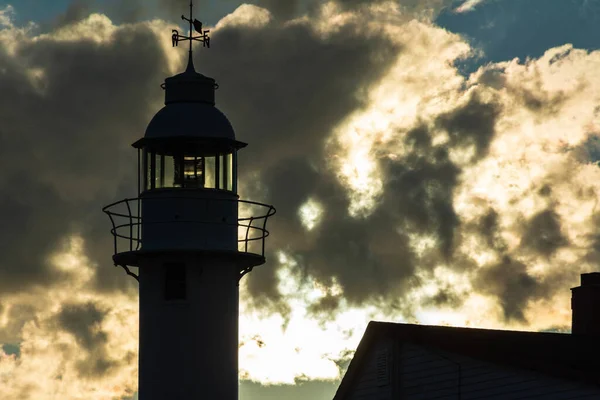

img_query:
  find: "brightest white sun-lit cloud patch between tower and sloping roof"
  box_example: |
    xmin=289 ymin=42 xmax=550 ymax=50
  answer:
xmin=240 ymin=253 xmax=368 ymax=384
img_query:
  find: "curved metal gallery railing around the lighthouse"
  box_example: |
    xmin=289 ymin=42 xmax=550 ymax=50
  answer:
xmin=102 ymin=196 xmax=276 ymax=257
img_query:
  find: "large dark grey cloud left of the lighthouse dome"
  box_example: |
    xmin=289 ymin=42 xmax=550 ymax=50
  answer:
xmin=0 ymin=17 xmax=171 ymax=293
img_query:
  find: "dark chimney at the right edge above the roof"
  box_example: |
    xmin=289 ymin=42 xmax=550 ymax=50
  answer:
xmin=571 ymin=272 xmax=600 ymax=335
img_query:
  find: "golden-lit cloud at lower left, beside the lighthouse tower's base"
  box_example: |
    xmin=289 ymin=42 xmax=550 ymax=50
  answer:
xmin=0 ymin=240 xmax=137 ymax=399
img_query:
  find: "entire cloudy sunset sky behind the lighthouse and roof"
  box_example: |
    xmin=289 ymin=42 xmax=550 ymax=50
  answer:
xmin=0 ymin=0 xmax=600 ymax=400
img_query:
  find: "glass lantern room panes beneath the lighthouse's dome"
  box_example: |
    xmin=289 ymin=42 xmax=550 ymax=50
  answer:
xmin=140 ymin=149 xmax=237 ymax=192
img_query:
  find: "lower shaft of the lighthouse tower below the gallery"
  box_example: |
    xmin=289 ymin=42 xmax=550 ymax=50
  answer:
xmin=139 ymin=252 xmax=239 ymax=400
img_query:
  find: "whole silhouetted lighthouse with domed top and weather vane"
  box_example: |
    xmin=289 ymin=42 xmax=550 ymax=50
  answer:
xmin=103 ymin=3 xmax=275 ymax=400
